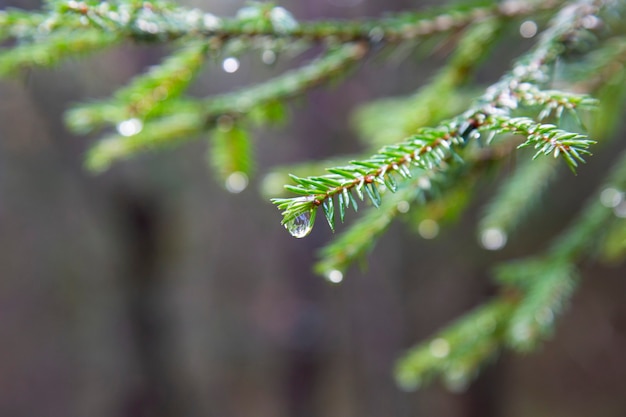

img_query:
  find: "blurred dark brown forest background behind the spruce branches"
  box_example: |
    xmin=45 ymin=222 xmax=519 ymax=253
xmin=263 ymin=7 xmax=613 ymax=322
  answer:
xmin=0 ymin=0 xmax=626 ymax=417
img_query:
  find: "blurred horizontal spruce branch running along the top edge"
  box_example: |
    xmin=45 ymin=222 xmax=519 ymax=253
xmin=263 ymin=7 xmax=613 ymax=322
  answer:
xmin=50 ymin=0 xmax=561 ymax=43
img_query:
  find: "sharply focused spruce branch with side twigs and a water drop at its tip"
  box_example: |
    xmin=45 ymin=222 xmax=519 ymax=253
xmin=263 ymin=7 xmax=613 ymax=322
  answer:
xmin=272 ymin=3 xmax=597 ymax=237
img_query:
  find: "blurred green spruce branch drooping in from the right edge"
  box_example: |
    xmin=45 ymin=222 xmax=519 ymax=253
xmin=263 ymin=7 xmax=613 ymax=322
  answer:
xmin=488 ymin=150 xmax=626 ymax=351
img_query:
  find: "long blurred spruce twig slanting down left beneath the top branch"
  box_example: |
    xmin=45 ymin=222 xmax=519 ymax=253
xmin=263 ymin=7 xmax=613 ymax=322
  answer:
xmin=83 ymin=44 xmax=367 ymax=171
